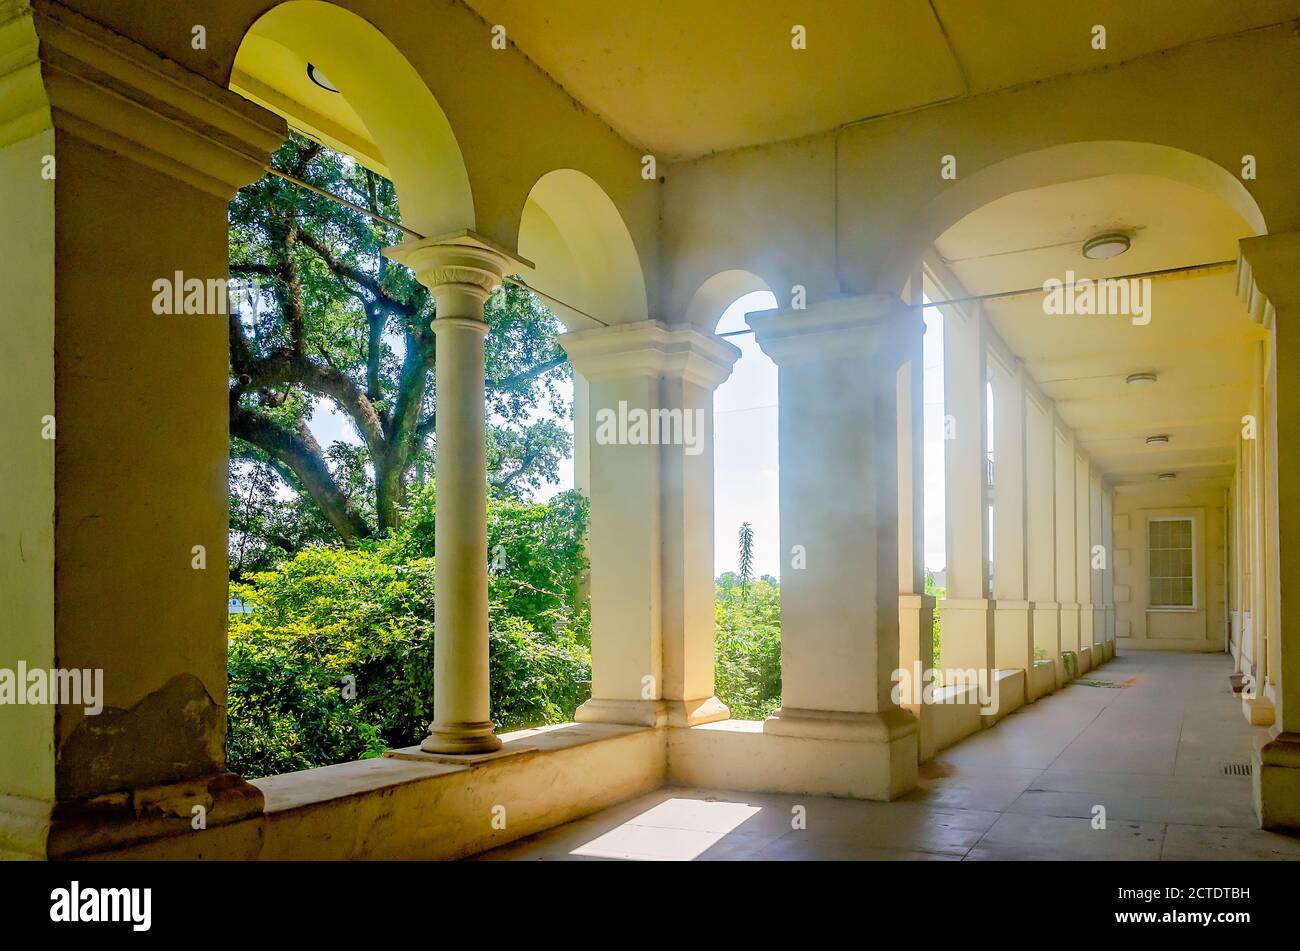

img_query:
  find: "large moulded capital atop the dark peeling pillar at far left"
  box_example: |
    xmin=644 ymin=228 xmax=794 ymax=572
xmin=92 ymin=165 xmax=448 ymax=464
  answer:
xmin=0 ymin=1 xmax=287 ymax=194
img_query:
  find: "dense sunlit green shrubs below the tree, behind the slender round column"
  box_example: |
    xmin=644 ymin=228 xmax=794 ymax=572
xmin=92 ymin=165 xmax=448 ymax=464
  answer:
xmin=229 ymin=483 xmax=590 ymax=776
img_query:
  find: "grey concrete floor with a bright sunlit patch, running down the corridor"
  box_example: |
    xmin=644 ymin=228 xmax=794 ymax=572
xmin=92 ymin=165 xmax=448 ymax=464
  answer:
xmin=477 ymin=651 xmax=1300 ymax=861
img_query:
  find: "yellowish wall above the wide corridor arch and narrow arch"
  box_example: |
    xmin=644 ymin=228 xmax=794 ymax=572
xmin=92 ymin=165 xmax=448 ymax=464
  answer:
xmin=662 ymin=25 xmax=1300 ymax=313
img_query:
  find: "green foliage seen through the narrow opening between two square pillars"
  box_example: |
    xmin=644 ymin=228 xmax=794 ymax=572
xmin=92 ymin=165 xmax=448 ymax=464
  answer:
xmin=714 ymin=572 xmax=781 ymax=720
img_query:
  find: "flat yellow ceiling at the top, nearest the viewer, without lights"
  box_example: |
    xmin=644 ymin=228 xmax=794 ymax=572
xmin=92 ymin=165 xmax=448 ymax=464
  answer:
xmin=463 ymin=0 xmax=1297 ymax=161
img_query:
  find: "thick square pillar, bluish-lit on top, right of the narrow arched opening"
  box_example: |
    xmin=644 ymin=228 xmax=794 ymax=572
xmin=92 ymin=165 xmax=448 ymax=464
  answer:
xmin=749 ymin=296 xmax=920 ymax=795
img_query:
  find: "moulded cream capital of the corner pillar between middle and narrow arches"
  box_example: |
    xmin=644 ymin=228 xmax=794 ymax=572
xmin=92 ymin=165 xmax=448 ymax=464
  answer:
xmin=559 ymin=320 xmax=740 ymax=390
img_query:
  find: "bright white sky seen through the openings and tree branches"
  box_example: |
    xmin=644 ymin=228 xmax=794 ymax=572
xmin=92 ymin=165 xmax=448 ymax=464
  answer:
xmin=299 ymin=291 xmax=945 ymax=578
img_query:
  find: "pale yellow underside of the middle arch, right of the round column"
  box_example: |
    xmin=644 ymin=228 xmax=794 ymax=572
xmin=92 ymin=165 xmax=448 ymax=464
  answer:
xmin=519 ymin=169 xmax=649 ymax=330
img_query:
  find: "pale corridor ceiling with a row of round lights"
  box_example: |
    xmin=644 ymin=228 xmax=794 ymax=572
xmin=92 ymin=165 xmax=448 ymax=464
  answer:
xmin=935 ymin=174 xmax=1262 ymax=485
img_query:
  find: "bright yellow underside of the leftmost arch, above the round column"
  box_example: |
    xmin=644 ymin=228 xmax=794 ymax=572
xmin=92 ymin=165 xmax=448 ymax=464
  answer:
xmin=231 ymin=0 xmax=475 ymax=236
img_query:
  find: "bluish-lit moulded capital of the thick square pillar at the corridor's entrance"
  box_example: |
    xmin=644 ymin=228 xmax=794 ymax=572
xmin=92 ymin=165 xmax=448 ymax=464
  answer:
xmin=746 ymin=294 xmax=924 ymax=365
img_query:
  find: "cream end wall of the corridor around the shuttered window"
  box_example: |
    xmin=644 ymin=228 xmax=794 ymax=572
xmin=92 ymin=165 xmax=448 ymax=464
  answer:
xmin=1114 ymin=481 xmax=1227 ymax=651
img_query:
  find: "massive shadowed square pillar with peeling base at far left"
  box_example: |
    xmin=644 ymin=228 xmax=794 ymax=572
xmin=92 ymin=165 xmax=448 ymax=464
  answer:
xmin=0 ymin=3 xmax=286 ymax=859
